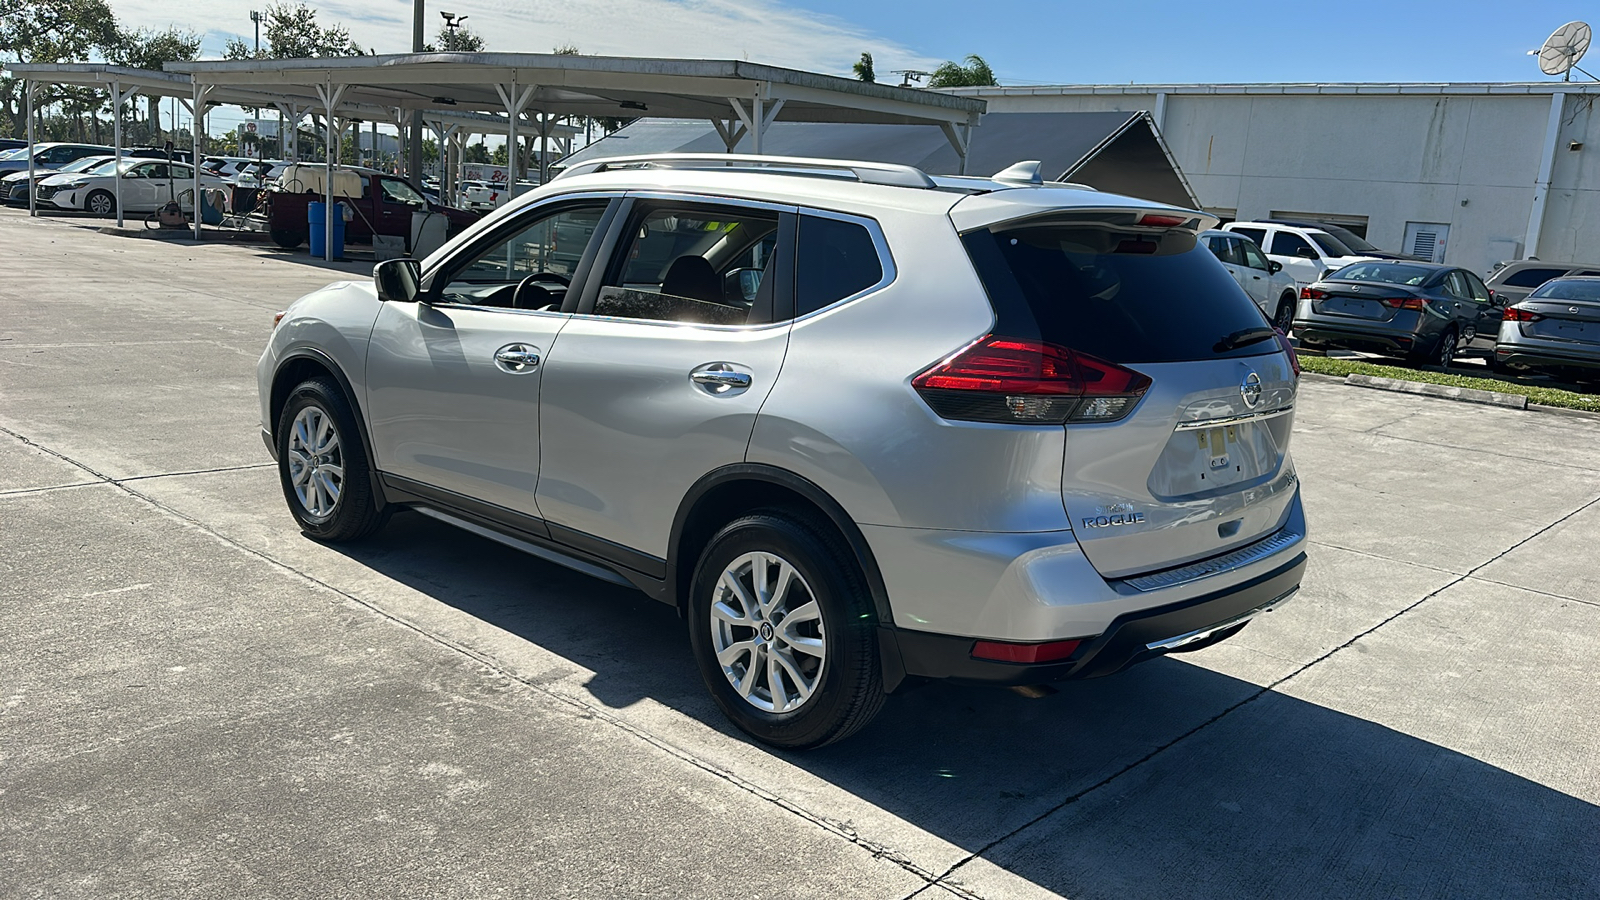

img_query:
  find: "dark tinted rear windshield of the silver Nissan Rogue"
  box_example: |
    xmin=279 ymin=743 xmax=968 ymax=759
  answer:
xmin=962 ymin=226 xmax=1277 ymax=364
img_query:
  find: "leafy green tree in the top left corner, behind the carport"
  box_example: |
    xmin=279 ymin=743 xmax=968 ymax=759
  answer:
xmin=0 ymin=0 xmax=120 ymax=138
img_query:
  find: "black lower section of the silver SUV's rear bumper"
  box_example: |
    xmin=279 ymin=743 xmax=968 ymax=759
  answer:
xmin=880 ymin=552 xmax=1306 ymax=689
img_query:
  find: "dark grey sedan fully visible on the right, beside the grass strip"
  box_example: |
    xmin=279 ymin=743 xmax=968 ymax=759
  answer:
xmin=1294 ymin=261 xmax=1501 ymax=367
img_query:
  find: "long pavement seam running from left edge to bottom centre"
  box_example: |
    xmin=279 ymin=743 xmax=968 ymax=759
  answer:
xmin=0 ymin=426 xmax=947 ymax=900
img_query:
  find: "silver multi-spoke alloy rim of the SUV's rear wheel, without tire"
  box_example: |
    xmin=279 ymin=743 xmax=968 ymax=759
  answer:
xmin=710 ymin=551 xmax=827 ymax=713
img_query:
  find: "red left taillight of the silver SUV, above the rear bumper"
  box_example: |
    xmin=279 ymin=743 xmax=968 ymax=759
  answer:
xmin=910 ymin=335 xmax=1150 ymax=424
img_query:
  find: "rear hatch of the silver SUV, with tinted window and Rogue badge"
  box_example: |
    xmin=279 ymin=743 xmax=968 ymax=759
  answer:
xmin=947 ymin=200 xmax=1298 ymax=578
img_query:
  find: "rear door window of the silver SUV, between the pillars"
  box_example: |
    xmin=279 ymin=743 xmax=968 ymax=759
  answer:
xmin=594 ymin=205 xmax=778 ymax=325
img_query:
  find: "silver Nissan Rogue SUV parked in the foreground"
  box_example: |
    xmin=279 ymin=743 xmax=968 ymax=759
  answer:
xmin=259 ymin=154 xmax=1306 ymax=748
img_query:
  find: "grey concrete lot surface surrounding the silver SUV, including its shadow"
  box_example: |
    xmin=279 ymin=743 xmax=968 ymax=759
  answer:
xmin=0 ymin=204 xmax=1600 ymax=898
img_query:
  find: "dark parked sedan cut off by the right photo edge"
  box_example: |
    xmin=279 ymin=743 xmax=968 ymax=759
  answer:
xmin=1494 ymin=277 xmax=1600 ymax=381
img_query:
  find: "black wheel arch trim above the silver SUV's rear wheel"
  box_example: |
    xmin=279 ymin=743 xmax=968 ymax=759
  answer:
xmin=667 ymin=463 xmax=894 ymax=626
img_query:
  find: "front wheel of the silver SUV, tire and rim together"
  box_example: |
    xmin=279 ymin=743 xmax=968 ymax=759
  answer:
xmin=277 ymin=378 xmax=382 ymax=541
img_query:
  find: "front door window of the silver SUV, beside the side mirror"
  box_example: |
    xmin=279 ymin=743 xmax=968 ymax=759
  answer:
xmin=438 ymin=200 xmax=606 ymax=311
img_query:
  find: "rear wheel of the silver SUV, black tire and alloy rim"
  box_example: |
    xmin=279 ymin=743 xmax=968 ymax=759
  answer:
xmin=690 ymin=509 xmax=883 ymax=749
